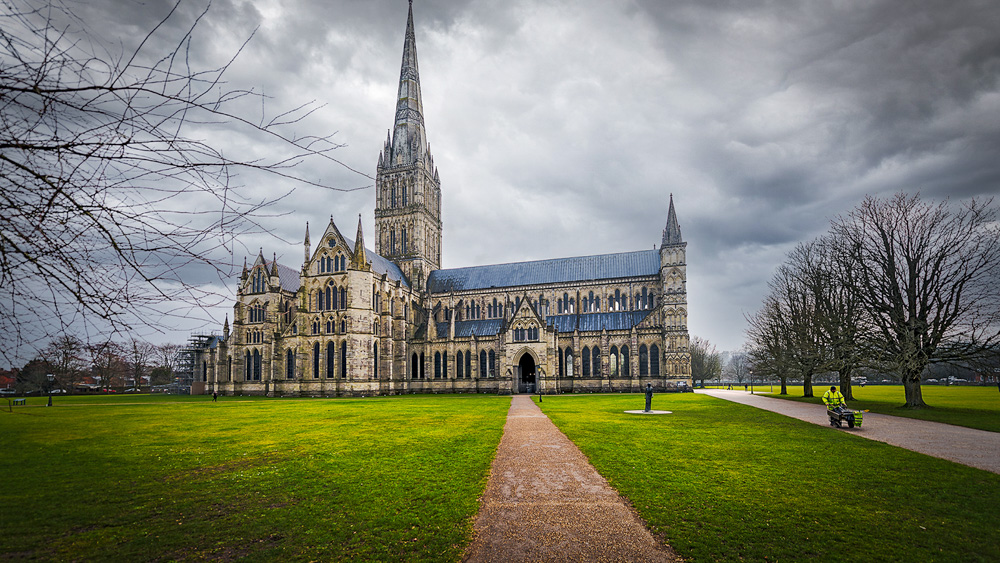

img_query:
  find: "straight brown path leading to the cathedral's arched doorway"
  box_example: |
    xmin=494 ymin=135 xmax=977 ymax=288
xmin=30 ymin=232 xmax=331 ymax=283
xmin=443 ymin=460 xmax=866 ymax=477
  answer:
xmin=465 ymin=395 xmax=677 ymax=562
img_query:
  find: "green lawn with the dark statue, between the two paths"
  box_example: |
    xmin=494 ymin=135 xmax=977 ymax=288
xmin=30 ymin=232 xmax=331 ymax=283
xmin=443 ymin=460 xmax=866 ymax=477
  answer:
xmin=536 ymin=394 xmax=1000 ymax=562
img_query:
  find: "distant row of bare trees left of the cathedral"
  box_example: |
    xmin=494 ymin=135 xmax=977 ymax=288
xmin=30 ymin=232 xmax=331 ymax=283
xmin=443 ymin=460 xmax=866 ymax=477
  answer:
xmin=13 ymin=335 xmax=182 ymax=393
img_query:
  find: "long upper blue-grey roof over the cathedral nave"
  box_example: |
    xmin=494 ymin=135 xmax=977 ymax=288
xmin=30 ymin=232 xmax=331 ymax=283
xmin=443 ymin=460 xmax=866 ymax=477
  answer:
xmin=427 ymin=249 xmax=660 ymax=293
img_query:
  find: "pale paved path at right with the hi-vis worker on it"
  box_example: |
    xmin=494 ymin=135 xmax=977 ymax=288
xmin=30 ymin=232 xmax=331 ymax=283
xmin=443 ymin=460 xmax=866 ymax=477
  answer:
xmin=697 ymin=389 xmax=1000 ymax=473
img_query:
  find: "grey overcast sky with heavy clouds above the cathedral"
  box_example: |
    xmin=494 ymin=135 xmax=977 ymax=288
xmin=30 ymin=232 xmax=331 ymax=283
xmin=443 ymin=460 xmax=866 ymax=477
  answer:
xmin=41 ymin=0 xmax=1000 ymax=350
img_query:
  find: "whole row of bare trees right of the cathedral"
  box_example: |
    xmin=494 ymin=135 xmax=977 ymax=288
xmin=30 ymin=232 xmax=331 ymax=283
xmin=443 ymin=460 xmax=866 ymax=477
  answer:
xmin=747 ymin=193 xmax=1000 ymax=408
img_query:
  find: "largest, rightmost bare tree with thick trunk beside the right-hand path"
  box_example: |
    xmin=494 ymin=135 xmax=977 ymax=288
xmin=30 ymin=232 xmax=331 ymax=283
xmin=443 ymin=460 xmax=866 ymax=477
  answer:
xmin=832 ymin=193 xmax=1000 ymax=408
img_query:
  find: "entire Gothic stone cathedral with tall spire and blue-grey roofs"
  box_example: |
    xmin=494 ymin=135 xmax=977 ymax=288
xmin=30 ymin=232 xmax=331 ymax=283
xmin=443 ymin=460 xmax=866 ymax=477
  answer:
xmin=199 ymin=3 xmax=691 ymax=397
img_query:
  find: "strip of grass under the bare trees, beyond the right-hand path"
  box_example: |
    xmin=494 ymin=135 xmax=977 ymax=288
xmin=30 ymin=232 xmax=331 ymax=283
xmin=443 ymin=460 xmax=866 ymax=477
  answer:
xmin=757 ymin=383 xmax=1000 ymax=432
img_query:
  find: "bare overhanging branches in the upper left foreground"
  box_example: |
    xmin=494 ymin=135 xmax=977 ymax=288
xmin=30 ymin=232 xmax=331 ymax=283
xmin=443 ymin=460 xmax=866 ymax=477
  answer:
xmin=0 ymin=0 xmax=367 ymax=366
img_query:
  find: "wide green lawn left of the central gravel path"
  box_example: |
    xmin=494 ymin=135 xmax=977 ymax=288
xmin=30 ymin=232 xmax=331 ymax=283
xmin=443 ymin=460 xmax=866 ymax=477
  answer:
xmin=0 ymin=395 xmax=510 ymax=561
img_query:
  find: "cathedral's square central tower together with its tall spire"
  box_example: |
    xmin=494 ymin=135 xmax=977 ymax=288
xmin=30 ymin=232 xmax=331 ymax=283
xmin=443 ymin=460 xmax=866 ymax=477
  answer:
xmin=375 ymin=0 xmax=441 ymax=288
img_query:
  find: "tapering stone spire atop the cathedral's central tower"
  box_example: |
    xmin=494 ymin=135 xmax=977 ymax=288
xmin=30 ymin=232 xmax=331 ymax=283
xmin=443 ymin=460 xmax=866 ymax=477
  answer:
xmin=385 ymin=2 xmax=427 ymax=166
